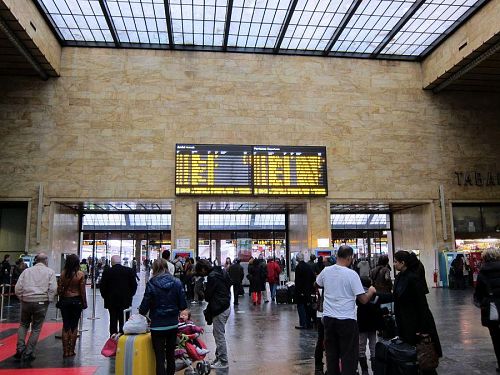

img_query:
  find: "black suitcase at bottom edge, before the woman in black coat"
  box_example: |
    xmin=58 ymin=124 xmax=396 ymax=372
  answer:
xmin=373 ymin=338 xmax=419 ymax=375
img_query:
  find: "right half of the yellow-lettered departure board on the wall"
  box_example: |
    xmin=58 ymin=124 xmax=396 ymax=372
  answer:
xmin=252 ymin=146 xmax=328 ymax=196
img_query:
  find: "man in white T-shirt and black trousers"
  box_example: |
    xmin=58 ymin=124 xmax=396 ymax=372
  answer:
xmin=316 ymin=245 xmax=376 ymax=375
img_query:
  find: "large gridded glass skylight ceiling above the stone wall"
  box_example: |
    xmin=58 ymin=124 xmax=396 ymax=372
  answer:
xmin=34 ymin=0 xmax=488 ymax=60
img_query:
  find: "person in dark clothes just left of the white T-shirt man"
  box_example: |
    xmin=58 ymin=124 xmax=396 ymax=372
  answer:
xmin=295 ymin=253 xmax=316 ymax=329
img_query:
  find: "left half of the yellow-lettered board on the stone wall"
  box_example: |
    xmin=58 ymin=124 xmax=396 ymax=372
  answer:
xmin=175 ymin=144 xmax=252 ymax=195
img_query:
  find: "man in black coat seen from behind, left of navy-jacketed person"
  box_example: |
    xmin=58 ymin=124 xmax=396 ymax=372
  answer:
xmin=100 ymin=255 xmax=137 ymax=335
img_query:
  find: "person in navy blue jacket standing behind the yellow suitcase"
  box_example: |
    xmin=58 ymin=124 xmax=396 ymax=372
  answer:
xmin=139 ymin=258 xmax=187 ymax=375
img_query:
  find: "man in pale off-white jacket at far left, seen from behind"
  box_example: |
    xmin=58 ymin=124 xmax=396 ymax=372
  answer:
xmin=15 ymin=253 xmax=57 ymax=361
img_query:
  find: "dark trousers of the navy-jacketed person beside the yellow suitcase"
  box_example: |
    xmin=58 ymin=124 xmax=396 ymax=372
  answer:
xmin=151 ymin=329 xmax=177 ymax=375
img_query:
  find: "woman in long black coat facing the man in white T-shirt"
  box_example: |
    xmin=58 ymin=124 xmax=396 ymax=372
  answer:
xmin=393 ymin=251 xmax=443 ymax=375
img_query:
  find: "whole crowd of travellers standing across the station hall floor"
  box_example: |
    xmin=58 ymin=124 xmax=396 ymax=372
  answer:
xmin=2 ymin=246 xmax=500 ymax=375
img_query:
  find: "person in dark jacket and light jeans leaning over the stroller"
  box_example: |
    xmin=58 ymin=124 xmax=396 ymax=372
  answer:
xmin=196 ymin=259 xmax=231 ymax=369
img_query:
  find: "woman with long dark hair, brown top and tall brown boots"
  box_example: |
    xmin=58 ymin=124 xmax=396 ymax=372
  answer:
xmin=57 ymin=254 xmax=87 ymax=357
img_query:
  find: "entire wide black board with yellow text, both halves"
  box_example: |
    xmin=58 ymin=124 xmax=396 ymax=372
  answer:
xmin=175 ymin=144 xmax=328 ymax=196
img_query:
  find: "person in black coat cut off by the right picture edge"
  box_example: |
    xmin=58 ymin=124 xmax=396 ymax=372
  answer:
xmin=474 ymin=249 xmax=500 ymax=372
